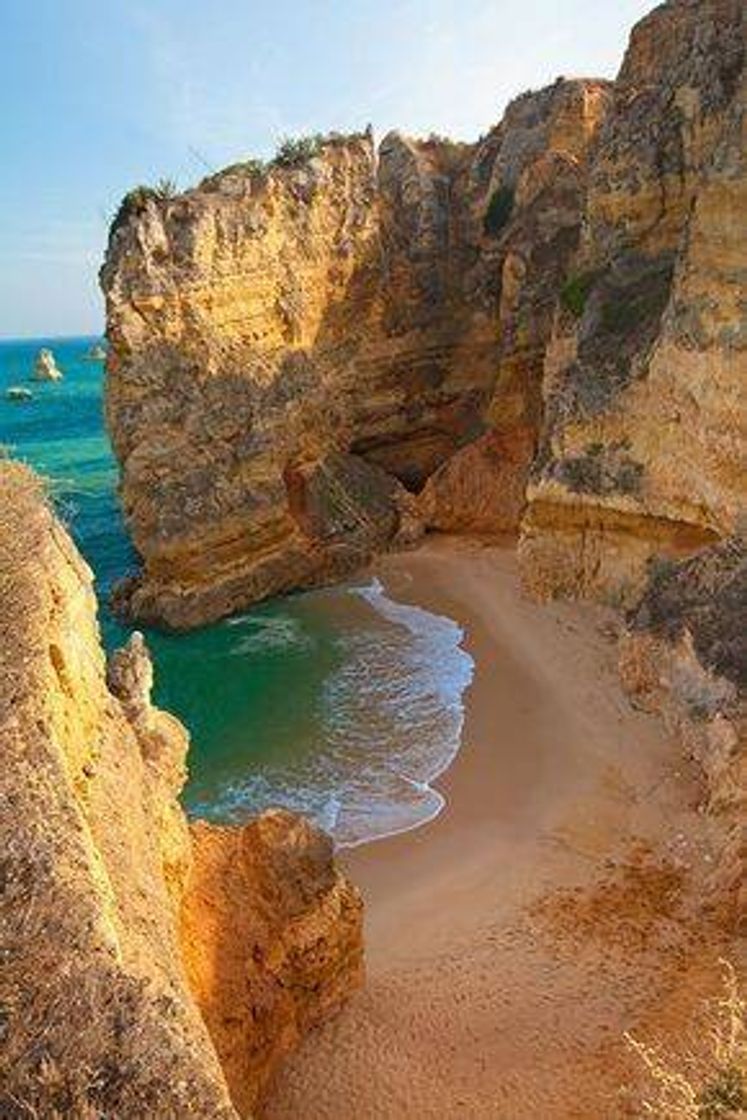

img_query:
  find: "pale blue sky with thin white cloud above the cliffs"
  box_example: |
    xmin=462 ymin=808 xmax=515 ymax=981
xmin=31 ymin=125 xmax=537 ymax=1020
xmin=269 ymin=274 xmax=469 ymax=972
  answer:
xmin=0 ymin=0 xmax=653 ymax=338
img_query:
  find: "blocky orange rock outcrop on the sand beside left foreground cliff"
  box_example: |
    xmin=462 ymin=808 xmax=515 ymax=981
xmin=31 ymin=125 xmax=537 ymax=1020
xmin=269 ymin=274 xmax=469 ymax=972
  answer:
xmin=181 ymin=810 xmax=363 ymax=1113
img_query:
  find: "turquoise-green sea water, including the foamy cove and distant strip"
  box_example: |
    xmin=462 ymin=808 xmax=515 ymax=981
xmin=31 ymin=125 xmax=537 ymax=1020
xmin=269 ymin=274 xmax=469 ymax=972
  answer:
xmin=0 ymin=338 xmax=471 ymax=846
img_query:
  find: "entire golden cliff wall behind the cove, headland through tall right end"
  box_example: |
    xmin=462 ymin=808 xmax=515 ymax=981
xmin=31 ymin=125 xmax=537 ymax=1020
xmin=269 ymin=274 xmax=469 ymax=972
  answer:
xmin=102 ymin=0 xmax=747 ymax=627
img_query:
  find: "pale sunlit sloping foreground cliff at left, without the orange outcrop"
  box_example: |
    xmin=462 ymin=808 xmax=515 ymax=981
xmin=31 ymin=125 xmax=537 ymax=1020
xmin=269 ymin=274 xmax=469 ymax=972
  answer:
xmin=0 ymin=463 xmax=235 ymax=1120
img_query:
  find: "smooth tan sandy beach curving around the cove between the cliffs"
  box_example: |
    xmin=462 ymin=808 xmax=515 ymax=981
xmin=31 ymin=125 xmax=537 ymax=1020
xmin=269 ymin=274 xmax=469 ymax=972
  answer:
xmin=261 ymin=538 xmax=723 ymax=1120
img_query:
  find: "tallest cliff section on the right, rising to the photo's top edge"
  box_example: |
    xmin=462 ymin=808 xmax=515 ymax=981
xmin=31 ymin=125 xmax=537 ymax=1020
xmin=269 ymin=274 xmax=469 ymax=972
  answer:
xmin=520 ymin=0 xmax=747 ymax=604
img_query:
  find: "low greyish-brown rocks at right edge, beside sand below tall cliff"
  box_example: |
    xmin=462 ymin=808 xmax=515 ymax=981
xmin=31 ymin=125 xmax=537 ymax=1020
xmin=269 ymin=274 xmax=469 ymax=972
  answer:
xmin=619 ymin=538 xmax=747 ymax=930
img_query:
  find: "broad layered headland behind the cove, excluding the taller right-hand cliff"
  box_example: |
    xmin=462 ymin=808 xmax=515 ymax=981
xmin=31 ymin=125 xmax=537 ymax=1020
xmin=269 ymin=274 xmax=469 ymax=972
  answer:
xmin=102 ymin=82 xmax=606 ymax=627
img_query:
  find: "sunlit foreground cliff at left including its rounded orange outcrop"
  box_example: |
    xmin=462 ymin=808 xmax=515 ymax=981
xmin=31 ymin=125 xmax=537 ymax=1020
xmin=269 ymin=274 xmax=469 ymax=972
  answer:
xmin=0 ymin=461 xmax=361 ymax=1120
